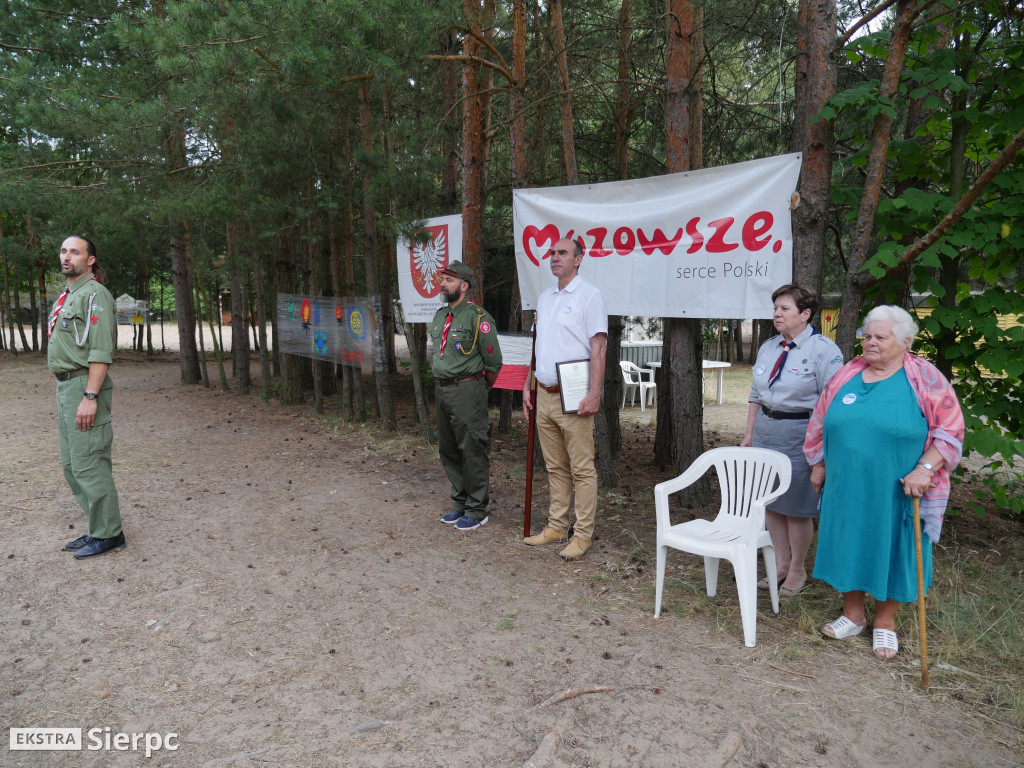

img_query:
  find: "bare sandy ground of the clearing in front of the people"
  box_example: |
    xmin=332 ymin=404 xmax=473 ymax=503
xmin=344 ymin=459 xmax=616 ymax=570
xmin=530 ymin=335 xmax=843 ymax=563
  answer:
xmin=0 ymin=355 xmax=1024 ymax=768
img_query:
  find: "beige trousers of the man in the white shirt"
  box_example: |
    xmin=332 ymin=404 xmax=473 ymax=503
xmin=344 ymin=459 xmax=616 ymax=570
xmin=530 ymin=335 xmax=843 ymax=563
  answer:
xmin=537 ymin=388 xmax=597 ymax=542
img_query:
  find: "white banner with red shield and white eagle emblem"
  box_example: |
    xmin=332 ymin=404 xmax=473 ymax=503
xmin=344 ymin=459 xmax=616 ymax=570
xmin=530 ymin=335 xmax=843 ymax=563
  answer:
xmin=396 ymin=214 xmax=462 ymax=323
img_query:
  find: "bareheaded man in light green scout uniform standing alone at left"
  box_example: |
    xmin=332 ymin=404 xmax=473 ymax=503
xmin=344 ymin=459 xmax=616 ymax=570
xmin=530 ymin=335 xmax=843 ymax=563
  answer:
xmin=47 ymin=237 xmax=125 ymax=559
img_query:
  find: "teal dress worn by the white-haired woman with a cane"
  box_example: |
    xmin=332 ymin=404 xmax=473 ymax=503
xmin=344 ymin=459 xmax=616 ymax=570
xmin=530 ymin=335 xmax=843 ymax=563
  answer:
xmin=814 ymin=369 xmax=932 ymax=602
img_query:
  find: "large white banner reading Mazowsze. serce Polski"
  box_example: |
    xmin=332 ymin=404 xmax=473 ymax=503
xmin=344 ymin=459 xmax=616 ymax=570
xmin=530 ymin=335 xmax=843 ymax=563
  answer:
xmin=512 ymin=154 xmax=801 ymax=318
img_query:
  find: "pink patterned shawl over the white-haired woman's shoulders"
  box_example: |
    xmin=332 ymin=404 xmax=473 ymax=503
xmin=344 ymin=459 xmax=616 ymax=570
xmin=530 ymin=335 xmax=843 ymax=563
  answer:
xmin=804 ymin=352 xmax=964 ymax=544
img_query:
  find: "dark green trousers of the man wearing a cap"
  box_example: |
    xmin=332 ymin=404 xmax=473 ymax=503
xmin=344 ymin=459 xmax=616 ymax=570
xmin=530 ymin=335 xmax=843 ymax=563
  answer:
xmin=434 ymin=378 xmax=490 ymax=520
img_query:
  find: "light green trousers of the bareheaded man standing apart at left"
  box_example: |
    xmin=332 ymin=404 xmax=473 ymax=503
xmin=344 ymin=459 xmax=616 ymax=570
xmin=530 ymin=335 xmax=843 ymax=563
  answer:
xmin=57 ymin=376 xmax=121 ymax=539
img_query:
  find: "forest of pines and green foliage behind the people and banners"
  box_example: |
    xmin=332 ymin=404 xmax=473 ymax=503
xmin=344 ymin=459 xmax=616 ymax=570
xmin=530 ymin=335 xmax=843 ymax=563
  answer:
xmin=0 ymin=0 xmax=1024 ymax=514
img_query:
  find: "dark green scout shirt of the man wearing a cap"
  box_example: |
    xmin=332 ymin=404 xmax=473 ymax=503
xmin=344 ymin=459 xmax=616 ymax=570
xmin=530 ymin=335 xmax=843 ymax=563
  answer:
xmin=430 ymin=301 xmax=502 ymax=379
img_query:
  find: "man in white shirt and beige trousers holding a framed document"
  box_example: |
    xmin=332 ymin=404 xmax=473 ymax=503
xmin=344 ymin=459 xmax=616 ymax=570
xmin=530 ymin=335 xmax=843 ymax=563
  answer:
xmin=522 ymin=240 xmax=608 ymax=560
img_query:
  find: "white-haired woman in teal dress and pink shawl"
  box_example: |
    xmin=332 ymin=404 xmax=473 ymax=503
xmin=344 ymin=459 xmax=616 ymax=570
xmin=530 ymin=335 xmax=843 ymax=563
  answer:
xmin=804 ymin=306 xmax=964 ymax=658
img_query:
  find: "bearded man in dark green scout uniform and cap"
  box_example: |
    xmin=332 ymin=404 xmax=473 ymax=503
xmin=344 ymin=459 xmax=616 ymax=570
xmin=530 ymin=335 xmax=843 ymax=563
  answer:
xmin=430 ymin=261 xmax=502 ymax=530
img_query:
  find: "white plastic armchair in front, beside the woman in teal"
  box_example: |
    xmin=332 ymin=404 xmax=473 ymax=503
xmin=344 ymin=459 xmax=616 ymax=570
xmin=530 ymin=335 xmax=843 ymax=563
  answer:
xmin=654 ymin=447 xmax=793 ymax=648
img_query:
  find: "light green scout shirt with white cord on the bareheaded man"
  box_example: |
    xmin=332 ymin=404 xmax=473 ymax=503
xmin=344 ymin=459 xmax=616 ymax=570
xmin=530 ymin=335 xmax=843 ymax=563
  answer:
xmin=46 ymin=275 xmax=118 ymax=374
